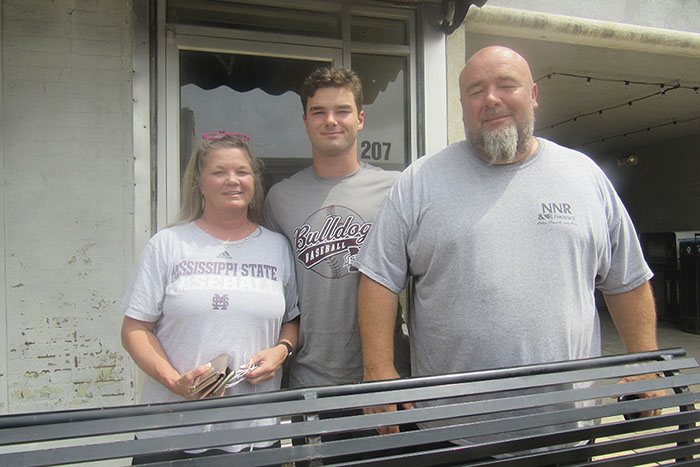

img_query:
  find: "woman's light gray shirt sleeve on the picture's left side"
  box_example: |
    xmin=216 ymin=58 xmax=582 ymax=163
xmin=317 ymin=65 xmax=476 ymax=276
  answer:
xmin=122 ymin=240 xmax=167 ymax=322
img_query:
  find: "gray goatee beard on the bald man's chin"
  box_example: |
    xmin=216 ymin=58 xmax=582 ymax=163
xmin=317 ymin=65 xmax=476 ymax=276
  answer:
xmin=466 ymin=113 xmax=535 ymax=165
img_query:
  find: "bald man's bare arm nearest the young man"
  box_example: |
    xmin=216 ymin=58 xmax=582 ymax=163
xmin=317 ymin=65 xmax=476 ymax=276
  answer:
xmin=357 ymin=274 xmax=413 ymax=434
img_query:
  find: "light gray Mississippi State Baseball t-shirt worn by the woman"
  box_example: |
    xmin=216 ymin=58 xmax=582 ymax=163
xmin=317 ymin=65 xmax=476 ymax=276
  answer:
xmin=122 ymin=222 xmax=299 ymax=451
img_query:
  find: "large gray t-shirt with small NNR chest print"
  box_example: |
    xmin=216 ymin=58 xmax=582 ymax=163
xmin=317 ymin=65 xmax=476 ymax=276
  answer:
xmin=355 ymin=139 xmax=652 ymax=376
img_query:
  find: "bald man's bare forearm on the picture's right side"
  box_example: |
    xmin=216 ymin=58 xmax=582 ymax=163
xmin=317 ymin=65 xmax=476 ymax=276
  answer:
xmin=603 ymin=282 xmax=665 ymax=416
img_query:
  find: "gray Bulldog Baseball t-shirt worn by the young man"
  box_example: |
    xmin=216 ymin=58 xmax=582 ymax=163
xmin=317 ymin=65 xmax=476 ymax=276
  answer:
xmin=265 ymin=163 xmax=407 ymax=387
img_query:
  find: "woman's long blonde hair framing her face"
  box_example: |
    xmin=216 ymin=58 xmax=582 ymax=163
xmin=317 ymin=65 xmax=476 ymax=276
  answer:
xmin=175 ymin=135 xmax=264 ymax=224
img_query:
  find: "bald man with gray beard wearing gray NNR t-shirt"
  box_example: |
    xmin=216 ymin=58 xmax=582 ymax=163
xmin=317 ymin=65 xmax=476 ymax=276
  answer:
xmin=355 ymin=47 xmax=658 ymax=432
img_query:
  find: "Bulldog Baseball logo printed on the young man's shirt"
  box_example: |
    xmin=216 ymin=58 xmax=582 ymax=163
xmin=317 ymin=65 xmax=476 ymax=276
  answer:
xmin=294 ymin=205 xmax=372 ymax=279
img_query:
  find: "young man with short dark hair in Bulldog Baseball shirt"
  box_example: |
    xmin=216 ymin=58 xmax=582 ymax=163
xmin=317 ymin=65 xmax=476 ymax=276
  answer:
xmin=264 ymin=68 xmax=408 ymax=387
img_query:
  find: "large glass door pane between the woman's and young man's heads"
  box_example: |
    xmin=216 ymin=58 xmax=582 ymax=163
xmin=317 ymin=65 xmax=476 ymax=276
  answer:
xmin=180 ymin=50 xmax=328 ymax=190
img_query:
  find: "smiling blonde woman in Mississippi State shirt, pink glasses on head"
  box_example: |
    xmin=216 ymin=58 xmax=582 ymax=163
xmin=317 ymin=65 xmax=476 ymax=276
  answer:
xmin=122 ymin=134 xmax=299 ymax=463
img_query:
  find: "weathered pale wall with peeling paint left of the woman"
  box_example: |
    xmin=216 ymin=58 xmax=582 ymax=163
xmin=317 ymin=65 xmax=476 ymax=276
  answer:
xmin=0 ymin=0 xmax=133 ymax=413
